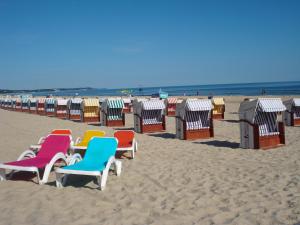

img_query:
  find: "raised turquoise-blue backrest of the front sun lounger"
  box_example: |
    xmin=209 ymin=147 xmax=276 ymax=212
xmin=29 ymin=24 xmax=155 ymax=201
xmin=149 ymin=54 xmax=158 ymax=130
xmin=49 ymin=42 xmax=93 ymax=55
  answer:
xmin=83 ymin=137 xmax=118 ymax=165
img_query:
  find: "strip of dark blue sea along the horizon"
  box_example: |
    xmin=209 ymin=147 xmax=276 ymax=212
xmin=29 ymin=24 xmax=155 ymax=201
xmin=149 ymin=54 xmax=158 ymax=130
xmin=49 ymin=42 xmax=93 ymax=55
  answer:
xmin=26 ymin=81 xmax=300 ymax=96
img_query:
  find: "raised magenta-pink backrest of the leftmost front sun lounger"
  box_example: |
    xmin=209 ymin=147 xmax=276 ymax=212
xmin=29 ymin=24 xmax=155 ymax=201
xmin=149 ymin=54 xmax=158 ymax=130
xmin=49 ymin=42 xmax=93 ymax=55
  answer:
xmin=37 ymin=135 xmax=71 ymax=159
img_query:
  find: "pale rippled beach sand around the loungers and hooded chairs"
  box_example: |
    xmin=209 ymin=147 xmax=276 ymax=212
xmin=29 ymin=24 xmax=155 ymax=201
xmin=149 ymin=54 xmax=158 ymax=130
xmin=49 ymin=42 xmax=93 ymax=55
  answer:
xmin=0 ymin=97 xmax=300 ymax=225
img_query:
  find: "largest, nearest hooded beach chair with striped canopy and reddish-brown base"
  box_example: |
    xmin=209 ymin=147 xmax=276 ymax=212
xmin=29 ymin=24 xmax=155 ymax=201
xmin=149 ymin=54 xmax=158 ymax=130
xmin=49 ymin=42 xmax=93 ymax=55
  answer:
xmin=239 ymin=98 xmax=286 ymax=149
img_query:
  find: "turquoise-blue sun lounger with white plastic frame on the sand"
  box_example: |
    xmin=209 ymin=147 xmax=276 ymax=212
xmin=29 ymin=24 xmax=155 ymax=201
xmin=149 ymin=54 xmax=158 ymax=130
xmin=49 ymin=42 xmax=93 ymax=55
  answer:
xmin=55 ymin=137 xmax=122 ymax=190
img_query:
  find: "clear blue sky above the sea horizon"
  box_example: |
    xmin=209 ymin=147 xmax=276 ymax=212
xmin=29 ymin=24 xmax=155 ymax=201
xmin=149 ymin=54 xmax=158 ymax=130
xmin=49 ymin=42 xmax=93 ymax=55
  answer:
xmin=0 ymin=0 xmax=300 ymax=89
